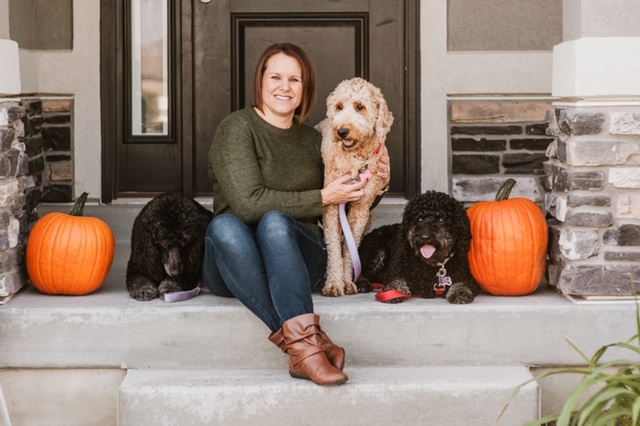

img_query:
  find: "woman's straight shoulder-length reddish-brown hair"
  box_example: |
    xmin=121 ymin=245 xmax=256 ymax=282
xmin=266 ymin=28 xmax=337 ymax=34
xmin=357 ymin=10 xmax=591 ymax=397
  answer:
xmin=253 ymin=43 xmax=316 ymax=123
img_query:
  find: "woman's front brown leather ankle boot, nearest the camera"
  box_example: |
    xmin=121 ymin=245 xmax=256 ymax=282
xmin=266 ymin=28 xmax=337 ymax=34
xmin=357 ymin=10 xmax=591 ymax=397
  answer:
xmin=282 ymin=314 xmax=349 ymax=386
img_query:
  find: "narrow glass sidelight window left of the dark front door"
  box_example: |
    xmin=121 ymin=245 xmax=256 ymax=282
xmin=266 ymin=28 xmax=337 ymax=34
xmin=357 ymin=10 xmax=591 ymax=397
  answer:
xmin=125 ymin=0 xmax=172 ymax=138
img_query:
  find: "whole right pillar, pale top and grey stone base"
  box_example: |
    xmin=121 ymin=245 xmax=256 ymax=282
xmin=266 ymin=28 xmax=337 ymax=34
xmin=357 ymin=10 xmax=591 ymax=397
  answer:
xmin=545 ymin=0 xmax=640 ymax=296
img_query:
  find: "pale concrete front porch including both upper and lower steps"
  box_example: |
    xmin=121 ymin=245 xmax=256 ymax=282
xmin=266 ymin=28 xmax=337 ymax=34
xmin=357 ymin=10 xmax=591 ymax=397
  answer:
xmin=0 ymin=203 xmax=636 ymax=425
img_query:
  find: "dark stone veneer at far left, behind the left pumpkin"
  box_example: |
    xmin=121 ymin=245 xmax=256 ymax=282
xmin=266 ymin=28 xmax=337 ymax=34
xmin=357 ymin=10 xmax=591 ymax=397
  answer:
xmin=0 ymin=96 xmax=73 ymax=299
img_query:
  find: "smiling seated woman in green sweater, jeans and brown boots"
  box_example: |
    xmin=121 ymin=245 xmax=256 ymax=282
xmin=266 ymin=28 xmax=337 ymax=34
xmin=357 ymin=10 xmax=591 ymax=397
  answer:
xmin=203 ymin=43 xmax=389 ymax=385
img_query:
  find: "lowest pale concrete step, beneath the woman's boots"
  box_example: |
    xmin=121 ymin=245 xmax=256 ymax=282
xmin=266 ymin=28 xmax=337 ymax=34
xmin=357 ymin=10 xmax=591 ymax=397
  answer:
xmin=118 ymin=365 xmax=539 ymax=426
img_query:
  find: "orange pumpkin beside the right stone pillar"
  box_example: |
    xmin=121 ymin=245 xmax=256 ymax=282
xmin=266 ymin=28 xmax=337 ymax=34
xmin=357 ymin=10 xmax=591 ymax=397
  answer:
xmin=467 ymin=179 xmax=549 ymax=296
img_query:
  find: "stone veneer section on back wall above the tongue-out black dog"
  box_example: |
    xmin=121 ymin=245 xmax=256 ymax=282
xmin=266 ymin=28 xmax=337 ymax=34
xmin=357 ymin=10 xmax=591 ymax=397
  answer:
xmin=449 ymin=97 xmax=553 ymax=205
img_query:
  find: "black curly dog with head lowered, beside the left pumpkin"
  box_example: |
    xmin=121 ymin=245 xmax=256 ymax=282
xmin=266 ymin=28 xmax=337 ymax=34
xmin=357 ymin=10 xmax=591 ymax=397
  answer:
xmin=126 ymin=193 xmax=213 ymax=302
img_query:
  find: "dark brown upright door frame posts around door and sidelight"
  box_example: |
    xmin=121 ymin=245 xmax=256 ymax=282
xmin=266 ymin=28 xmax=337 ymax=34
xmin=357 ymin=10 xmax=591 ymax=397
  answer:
xmin=100 ymin=0 xmax=421 ymax=203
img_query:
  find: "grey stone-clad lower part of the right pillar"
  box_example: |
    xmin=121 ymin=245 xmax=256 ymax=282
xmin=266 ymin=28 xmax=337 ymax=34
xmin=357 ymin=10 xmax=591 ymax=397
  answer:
xmin=546 ymin=102 xmax=640 ymax=296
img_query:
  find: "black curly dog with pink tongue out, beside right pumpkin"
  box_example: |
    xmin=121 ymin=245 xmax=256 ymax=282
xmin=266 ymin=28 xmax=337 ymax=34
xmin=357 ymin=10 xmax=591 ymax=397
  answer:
xmin=356 ymin=191 xmax=480 ymax=304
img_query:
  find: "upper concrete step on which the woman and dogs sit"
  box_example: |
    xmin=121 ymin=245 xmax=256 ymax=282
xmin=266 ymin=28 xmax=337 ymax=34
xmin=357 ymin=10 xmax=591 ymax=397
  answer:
xmin=0 ymin=245 xmax=636 ymax=369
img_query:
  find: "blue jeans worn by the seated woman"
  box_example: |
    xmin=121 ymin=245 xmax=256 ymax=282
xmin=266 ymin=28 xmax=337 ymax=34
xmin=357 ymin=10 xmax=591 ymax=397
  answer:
xmin=202 ymin=211 xmax=327 ymax=332
